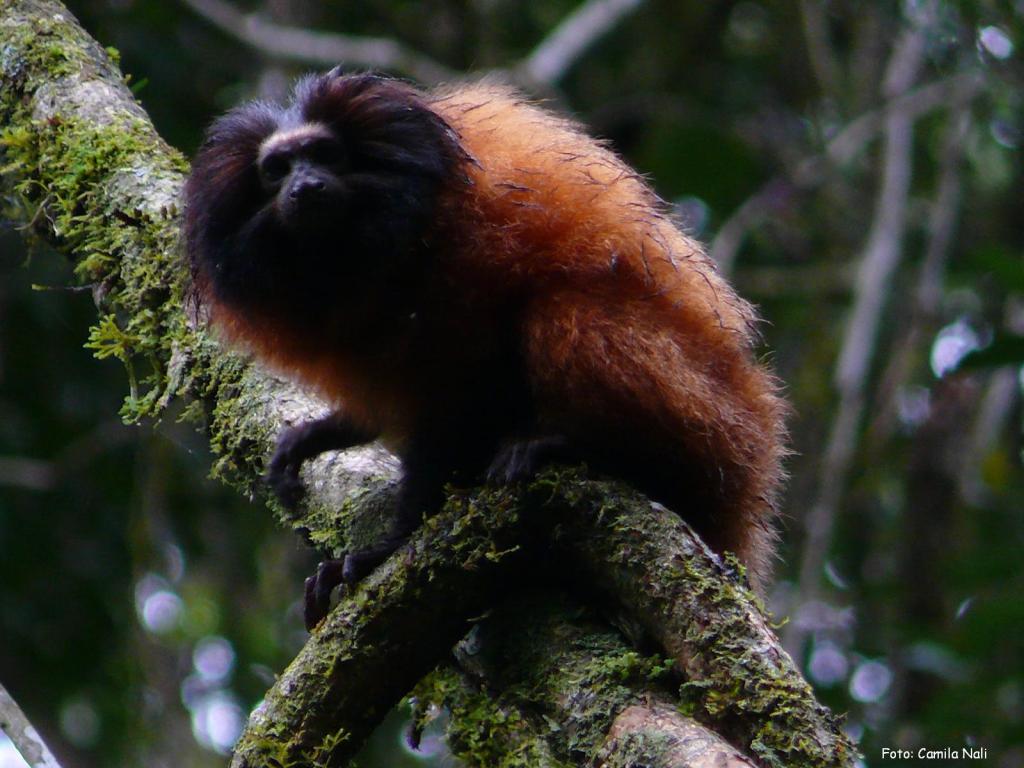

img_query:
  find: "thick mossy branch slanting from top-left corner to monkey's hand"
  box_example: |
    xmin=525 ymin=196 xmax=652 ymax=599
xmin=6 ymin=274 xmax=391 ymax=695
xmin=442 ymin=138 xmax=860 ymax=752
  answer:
xmin=0 ymin=0 xmax=392 ymax=541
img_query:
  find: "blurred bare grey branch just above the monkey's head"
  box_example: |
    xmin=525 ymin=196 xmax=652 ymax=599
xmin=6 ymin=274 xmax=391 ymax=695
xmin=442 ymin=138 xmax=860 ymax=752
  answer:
xmin=181 ymin=0 xmax=457 ymax=83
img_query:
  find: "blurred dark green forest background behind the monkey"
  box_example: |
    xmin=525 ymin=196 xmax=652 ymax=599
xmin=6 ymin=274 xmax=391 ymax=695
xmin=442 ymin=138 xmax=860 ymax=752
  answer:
xmin=0 ymin=0 xmax=1024 ymax=768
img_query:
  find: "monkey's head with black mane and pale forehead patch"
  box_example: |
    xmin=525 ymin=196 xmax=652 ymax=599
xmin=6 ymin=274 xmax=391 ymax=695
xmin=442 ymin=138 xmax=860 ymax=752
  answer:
xmin=184 ymin=73 xmax=466 ymax=331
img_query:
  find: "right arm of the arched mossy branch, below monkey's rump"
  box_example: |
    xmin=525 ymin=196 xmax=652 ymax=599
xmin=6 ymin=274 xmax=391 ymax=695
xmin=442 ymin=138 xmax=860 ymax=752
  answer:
xmin=547 ymin=483 xmax=856 ymax=766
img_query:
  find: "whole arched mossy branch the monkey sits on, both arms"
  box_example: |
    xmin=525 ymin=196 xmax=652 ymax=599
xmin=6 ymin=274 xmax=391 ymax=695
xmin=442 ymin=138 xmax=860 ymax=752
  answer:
xmin=232 ymin=470 xmax=856 ymax=768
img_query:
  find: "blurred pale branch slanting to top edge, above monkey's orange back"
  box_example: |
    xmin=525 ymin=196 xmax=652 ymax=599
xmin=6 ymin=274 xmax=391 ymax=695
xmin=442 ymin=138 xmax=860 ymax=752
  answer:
xmin=516 ymin=0 xmax=643 ymax=85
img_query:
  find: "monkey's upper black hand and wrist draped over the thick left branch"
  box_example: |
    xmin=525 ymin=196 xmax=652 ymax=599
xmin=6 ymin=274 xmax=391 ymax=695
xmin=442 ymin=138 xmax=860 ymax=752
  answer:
xmin=265 ymin=413 xmax=377 ymax=509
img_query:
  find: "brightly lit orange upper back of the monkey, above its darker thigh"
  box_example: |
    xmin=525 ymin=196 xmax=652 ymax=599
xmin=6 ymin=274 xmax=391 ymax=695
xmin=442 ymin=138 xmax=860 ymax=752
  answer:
xmin=432 ymin=83 xmax=755 ymax=333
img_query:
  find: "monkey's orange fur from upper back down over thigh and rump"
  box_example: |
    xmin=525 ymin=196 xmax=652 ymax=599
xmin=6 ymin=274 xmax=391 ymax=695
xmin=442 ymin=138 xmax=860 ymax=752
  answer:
xmin=431 ymin=83 xmax=785 ymax=585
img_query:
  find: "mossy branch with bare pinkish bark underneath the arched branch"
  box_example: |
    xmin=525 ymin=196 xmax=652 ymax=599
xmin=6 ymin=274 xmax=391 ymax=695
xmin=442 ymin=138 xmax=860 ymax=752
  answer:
xmin=432 ymin=593 xmax=755 ymax=768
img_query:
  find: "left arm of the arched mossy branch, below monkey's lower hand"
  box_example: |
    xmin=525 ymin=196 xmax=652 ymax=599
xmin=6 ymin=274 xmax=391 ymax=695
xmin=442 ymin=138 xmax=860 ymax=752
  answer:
xmin=231 ymin=489 xmax=540 ymax=768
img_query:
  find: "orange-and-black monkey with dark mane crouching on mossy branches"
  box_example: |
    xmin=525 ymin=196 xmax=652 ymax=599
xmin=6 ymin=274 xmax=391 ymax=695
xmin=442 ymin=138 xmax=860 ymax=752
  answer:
xmin=183 ymin=70 xmax=786 ymax=625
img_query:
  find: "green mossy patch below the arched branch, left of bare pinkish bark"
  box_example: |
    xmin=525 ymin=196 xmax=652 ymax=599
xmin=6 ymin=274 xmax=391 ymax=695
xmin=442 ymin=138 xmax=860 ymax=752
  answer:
xmin=417 ymin=593 xmax=672 ymax=768
